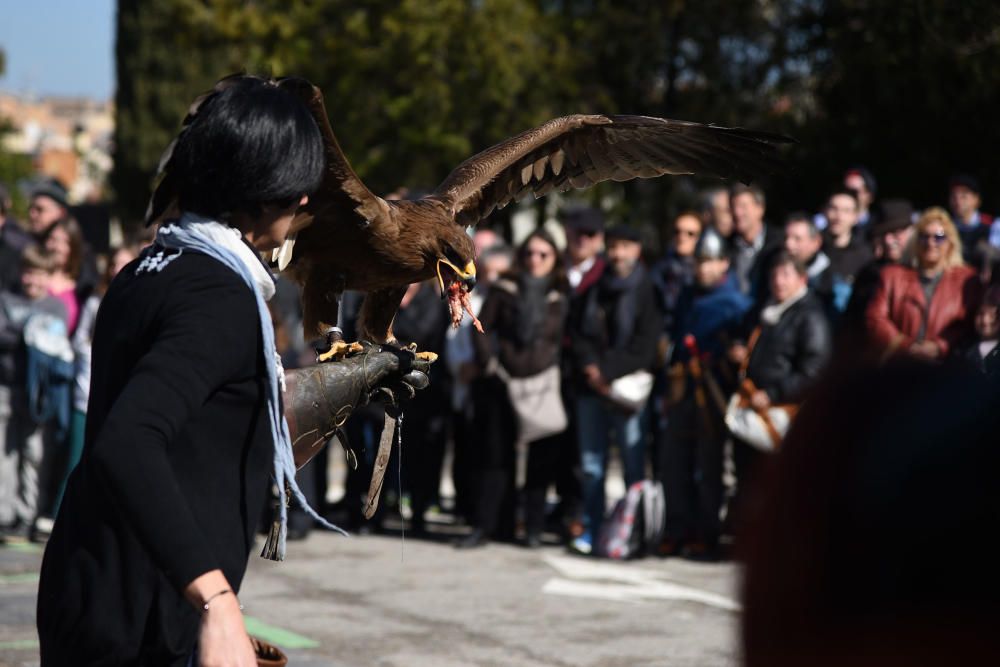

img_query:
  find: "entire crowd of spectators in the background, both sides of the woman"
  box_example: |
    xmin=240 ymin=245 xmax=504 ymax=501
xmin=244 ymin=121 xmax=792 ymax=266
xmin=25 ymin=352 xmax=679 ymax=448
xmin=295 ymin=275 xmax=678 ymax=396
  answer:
xmin=0 ymin=168 xmax=1000 ymax=559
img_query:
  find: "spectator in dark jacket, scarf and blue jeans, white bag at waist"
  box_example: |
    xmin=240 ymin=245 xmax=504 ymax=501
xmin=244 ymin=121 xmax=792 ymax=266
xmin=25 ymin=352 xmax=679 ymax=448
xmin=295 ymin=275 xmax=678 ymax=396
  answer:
xmin=569 ymin=227 xmax=663 ymax=553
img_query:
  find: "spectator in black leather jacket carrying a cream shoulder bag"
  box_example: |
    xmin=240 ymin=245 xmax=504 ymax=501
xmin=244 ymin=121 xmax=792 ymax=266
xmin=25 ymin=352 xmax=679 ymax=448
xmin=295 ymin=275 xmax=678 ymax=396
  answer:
xmin=730 ymin=252 xmax=833 ymax=521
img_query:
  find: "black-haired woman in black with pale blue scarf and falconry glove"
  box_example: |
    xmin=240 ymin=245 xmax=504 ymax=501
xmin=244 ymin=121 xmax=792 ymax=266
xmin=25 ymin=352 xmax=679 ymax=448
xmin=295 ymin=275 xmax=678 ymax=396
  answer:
xmin=38 ymin=76 xmax=426 ymax=666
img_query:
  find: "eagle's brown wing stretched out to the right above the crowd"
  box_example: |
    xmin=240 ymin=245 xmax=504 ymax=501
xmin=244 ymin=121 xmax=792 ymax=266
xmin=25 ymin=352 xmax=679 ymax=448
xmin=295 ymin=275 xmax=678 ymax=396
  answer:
xmin=432 ymin=115 xmax=792 ymax=225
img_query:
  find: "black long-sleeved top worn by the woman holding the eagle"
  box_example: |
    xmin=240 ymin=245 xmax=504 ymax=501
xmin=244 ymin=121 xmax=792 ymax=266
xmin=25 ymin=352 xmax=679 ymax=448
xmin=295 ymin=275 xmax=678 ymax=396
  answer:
xmin=38 ymin=251 xmax=273 ymax=665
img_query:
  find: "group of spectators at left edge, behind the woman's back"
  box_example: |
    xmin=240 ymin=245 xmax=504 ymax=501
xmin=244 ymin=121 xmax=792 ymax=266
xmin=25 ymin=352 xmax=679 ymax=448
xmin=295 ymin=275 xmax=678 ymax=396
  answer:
xmin=0 ymin=181 xmax=144 ymax=540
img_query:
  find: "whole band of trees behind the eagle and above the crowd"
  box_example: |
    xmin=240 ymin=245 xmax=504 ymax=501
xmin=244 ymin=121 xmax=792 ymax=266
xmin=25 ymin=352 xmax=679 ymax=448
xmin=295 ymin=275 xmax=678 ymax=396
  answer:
xmin=112 ymin=0 xmax=1000 ymax=230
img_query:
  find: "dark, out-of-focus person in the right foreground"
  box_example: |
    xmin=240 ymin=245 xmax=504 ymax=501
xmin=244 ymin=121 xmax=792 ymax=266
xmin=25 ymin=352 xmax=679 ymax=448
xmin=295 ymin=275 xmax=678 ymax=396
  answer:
xmin=741 ymin=360 xmax=1000 ymax=667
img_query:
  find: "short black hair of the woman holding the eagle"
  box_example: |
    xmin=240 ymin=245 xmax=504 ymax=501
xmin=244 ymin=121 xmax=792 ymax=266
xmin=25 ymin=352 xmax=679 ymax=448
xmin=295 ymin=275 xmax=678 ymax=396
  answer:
xmin=169 ymin=75 xmax=324 ymax=220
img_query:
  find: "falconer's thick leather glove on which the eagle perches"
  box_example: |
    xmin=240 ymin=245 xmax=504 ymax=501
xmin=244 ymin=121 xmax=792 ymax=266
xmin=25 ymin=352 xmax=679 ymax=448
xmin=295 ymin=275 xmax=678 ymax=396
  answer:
xmin=284 ymin=345 xmax=431 ymax=468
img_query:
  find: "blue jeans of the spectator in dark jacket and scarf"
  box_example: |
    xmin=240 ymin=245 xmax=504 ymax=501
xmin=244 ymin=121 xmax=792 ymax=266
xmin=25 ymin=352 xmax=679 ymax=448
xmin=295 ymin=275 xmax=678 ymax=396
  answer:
xmin=576 ymin=395 xmax=646 ymax=542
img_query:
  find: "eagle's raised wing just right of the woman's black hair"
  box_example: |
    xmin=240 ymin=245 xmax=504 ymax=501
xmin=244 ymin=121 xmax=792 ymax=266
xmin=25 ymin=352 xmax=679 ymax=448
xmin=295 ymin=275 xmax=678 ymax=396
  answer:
xmin=278 ymin=77 xmax=389 ymax=231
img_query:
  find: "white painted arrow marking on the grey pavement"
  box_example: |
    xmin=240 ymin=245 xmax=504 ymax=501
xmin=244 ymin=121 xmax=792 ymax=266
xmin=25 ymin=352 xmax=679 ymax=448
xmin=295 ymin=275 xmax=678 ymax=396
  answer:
xmin=542 ymin=555 xmax=741 ymax=611
